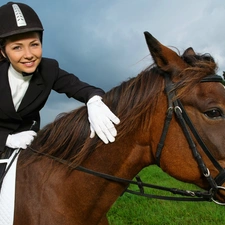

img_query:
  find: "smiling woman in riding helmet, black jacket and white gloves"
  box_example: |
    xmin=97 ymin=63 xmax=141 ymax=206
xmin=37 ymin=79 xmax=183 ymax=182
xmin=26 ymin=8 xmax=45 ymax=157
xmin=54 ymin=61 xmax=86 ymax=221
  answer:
xmin=0 ymin=2 xmax=119 ymax=162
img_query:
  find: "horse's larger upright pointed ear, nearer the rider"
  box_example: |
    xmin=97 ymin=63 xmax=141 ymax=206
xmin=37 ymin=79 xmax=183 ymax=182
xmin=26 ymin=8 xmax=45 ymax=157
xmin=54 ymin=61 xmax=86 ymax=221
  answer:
xmin=144 ymin=32 xmax=187 ymax=72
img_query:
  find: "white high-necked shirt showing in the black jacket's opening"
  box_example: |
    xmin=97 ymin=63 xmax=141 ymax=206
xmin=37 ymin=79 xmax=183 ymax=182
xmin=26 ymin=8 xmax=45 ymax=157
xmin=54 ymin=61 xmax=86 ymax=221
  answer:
xmin=8 ymin=64 xmax=32 ymax=111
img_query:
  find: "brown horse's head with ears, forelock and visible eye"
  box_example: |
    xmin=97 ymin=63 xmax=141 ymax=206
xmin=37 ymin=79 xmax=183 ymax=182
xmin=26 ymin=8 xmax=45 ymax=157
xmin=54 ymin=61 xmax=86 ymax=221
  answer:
xmin=145 ymin=32 xmax=225 ymax=202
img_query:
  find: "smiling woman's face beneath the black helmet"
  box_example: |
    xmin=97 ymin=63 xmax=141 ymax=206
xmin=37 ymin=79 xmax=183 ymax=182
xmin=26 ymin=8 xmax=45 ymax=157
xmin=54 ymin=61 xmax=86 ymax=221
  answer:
xmin=2 ymin=32 xmax=42 ymax=73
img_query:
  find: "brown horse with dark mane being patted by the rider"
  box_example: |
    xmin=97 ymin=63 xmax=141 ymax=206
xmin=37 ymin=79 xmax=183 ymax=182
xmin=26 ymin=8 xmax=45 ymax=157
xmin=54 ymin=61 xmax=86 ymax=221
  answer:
xmin=14 ymin=32 xmax=225 ymax=225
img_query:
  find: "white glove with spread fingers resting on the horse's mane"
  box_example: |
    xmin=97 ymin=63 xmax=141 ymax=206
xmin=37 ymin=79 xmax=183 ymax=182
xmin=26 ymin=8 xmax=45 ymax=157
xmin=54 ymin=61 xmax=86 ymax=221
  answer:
xmin=87 ymin=95 xmax=120 ymax=144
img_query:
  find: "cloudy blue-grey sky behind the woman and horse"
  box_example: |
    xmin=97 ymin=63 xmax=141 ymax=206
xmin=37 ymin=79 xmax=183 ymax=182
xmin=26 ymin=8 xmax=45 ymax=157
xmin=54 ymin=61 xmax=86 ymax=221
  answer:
xmin=0 ymin=0 xmax=225 ymax=126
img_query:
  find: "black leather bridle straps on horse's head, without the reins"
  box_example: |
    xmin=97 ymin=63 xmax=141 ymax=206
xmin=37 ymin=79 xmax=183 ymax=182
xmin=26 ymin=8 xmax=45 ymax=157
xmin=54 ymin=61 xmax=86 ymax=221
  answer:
xmin=156 ymin=75 xmax=225 ymax=205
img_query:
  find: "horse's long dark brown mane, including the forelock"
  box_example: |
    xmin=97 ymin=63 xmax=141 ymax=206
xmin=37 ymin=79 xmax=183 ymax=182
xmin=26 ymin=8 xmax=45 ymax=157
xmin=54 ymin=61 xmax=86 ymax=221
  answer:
xmin=24 ymin=50 xmax=216 ymax=166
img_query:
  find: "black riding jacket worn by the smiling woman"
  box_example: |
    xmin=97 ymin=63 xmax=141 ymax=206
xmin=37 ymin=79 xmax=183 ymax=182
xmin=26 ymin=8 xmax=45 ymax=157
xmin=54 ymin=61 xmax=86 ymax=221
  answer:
xmin=0 ymin=58 xmax=104 ymax=151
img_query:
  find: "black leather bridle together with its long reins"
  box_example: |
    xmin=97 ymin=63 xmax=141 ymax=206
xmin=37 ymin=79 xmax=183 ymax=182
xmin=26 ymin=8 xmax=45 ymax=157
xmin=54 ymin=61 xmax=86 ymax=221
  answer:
xmin=28 ymin=75 xmax=225 ymax=205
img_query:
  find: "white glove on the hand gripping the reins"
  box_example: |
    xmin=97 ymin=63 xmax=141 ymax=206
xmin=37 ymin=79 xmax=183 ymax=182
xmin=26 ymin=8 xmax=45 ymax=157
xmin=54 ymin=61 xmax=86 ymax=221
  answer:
xmin=6 ymin=130 xmax=37 ymax=149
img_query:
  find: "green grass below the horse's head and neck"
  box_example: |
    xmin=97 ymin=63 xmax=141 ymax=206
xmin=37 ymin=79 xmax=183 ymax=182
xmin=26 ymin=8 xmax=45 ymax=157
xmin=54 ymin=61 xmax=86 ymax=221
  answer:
xmin=108 ymin=166 xmax=225 ymax=225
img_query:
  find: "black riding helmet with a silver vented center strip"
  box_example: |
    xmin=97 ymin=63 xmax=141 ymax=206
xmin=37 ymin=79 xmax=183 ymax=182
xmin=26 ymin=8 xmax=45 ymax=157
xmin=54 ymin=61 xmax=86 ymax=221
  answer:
xmin=0 ymin=2 xmax=44 ymax=39
